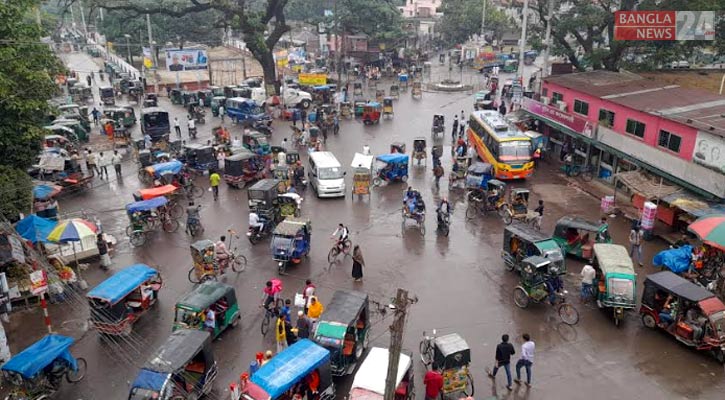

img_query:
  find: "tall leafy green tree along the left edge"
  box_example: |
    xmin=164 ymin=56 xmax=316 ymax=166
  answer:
xmin=0 ymin=0 xmax=63 ymax=220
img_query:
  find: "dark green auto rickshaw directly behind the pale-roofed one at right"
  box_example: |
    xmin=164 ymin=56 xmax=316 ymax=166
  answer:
xmin=554 ymin=217 xmax=612 ymax=260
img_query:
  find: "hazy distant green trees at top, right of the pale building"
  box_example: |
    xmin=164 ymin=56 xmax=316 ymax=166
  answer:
xmin=440 ymin=0 xmax=513 ymax=45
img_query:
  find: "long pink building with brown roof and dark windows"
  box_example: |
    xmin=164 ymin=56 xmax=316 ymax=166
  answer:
xmin=522 ymin=71 xmax=725 ymax=200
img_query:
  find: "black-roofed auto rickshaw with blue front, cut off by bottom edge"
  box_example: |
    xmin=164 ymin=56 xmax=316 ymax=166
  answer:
xmin=128 ymin=329 xmax=218 ymax=400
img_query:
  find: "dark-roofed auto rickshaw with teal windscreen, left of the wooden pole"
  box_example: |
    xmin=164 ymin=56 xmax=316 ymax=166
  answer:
xmin=312 ymin=290 xmax=370 ymax=376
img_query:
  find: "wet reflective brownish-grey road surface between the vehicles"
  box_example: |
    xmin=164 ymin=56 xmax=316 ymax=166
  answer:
xmin=8 ymin=54 xmax=725 ymax=399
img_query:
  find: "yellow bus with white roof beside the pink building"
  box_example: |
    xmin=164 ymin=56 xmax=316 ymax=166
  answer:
xmin=468 ymin=110 xmax=534 ymax=179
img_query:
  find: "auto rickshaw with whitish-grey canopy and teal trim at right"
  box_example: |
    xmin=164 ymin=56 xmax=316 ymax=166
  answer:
xmin=592 ymin=243 xmax=637 ymax=326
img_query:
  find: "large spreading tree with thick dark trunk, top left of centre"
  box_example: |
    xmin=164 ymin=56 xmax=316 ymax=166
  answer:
xmin=89 ymin=0 xmax=290 ymax=94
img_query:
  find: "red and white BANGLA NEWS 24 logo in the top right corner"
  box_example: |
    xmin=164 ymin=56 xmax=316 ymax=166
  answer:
xmin=614 ymin=11 xmax=715 ymax=40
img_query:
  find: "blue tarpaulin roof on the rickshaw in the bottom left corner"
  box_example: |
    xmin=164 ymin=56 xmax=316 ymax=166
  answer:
xmin=2 ymin=334 xmax=78 ymax=379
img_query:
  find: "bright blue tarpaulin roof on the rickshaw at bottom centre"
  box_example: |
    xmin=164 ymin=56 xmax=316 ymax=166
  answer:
xmin=252 ymin=339 xmax=330 ymax=399
